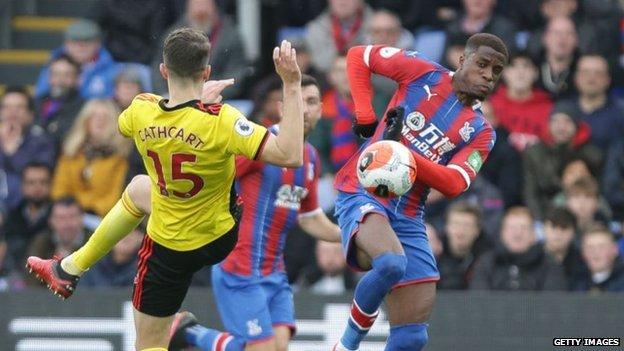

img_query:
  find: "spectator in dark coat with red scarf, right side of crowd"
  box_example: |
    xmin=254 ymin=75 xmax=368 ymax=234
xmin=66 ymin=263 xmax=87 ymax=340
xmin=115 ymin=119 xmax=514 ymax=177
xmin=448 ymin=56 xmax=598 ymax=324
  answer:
xmin=523 ymin=103 xmax=602 ymax=221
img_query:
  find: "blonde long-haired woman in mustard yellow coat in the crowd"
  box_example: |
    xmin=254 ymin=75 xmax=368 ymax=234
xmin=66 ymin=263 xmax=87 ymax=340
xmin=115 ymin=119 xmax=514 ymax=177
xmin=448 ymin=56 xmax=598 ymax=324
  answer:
xmin=51 ymin=100 xmax=130 ymax=219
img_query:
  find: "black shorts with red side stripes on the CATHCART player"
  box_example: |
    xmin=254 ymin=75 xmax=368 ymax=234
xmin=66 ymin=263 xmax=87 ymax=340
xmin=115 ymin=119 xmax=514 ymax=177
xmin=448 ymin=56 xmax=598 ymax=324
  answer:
xmin=132 ymin=225 xmax=238 ymax=317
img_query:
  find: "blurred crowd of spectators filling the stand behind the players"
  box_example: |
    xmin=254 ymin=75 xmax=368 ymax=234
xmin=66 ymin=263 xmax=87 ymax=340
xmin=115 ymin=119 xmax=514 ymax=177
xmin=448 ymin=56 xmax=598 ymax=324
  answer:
xmin=0 ymin=0 xmax=624 ymax=294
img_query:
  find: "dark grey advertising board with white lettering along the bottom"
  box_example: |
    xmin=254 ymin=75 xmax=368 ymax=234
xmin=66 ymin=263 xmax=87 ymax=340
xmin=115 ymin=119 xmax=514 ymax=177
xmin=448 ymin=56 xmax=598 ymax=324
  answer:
xmin=0 ymin=289 xmax=624 ymax=351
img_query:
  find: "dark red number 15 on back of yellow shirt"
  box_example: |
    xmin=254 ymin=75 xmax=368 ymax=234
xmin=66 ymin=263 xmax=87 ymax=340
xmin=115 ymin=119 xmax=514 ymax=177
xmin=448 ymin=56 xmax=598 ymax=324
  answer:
xmin=147 ymin=150 xmax=204 ymax=199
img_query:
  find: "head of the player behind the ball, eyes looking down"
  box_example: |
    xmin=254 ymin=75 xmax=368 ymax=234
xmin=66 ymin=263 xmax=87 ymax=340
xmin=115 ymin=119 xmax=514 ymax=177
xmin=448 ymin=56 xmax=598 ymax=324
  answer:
xmin=454 ymin=33 xmax=509 ymax=100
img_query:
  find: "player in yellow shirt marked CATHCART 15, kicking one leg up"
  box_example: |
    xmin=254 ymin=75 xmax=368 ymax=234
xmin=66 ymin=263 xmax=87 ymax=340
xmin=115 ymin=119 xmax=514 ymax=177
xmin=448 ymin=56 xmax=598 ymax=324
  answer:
xmin=27 ymin=28 xmax=303 ymax=351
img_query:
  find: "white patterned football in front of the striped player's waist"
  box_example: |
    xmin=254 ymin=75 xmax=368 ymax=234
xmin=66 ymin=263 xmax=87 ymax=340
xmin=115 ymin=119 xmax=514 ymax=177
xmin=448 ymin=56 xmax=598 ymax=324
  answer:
xmin=357 ymin=140 xmax=416 ymax=198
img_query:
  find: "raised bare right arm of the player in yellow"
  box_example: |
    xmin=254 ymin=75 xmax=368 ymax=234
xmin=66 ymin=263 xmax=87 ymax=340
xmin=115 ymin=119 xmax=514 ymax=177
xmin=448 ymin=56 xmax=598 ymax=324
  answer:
xmin=260 ymin=40 xmax=303 ymax=167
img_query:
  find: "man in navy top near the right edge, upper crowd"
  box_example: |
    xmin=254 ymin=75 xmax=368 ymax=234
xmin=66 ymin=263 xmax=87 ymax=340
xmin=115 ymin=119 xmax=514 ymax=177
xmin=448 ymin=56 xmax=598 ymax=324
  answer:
xmin=574 ymin=55 xmax=624 ymax=153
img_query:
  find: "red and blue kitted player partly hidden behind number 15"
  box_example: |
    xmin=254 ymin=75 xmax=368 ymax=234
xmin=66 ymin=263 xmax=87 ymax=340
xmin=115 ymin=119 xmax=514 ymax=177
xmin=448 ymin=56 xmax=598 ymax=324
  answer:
xmin=169 ymin=75 xmax=340 ymax=351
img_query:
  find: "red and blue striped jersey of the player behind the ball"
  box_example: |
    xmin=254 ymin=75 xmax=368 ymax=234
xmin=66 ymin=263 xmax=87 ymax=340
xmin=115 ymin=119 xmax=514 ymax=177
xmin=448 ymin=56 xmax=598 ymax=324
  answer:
xmin=335 ymin=45 xmax=496 ymax=219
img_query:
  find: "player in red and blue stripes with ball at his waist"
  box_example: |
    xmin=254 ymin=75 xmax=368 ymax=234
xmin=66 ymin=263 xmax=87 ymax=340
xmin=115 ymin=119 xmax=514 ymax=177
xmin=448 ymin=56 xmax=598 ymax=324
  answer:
xmin=334 ymin=33 xmax=508 ymax=351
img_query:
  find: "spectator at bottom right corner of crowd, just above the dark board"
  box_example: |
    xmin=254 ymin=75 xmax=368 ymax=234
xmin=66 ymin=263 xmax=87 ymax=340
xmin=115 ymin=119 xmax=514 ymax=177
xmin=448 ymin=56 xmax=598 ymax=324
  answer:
xmin=573 ymin=226 xmax=624 ymax=292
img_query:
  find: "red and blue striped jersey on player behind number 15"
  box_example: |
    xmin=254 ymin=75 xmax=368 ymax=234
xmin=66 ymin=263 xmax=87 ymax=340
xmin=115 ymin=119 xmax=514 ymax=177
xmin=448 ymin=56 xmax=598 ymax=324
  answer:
xmin=221 ymin=133 xmax=322 ymax=276
